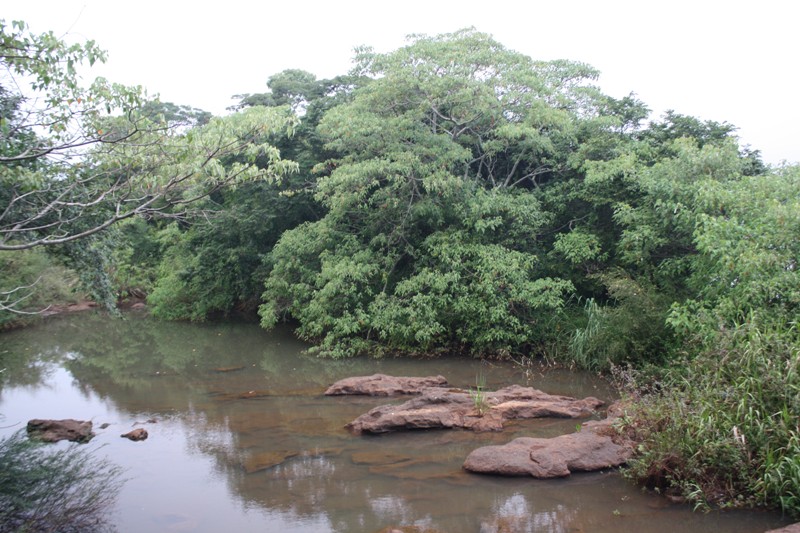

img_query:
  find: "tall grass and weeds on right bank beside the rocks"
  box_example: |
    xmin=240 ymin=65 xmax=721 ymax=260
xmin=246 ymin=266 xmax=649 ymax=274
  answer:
xmin=628 ymin=315 xmax=800 ymax=516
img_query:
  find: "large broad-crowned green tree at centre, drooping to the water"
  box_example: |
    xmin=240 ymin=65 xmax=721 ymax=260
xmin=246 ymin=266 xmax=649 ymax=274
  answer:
xmin=261 ymin=29 xmax=602 ymax=355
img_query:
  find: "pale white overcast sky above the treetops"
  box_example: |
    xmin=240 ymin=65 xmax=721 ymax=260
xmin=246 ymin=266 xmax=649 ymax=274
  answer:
xmin=6 ymin=0 xmax=800 ymax=164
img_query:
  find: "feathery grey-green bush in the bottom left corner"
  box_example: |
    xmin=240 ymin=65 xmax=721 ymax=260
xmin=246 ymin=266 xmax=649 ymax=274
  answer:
xmin=0 ymin=431 xmax=122 ymax=533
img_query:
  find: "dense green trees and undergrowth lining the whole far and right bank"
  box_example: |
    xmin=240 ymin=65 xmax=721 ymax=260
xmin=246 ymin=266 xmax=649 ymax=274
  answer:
xmin=0 ymin=20 xmax=800 ymax=515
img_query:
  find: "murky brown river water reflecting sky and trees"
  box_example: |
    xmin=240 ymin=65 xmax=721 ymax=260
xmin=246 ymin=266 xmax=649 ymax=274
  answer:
xmin=0 ymin=312 xmax=788 ymax=533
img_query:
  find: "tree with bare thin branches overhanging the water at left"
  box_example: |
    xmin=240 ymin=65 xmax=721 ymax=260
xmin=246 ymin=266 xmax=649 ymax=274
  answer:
xmin=0 ymin=21 xmax=297 ymax=310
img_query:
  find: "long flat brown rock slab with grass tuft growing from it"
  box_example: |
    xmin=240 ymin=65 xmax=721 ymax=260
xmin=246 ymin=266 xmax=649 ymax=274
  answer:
xmin=347 ymin=385 xmax=603 ymax=434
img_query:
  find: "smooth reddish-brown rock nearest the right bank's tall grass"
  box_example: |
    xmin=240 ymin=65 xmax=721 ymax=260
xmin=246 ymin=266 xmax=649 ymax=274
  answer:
xmin=464 ymin=404 xmax=633 ymax=478
